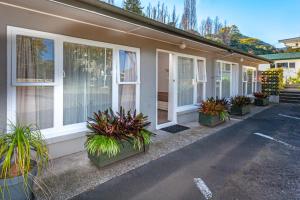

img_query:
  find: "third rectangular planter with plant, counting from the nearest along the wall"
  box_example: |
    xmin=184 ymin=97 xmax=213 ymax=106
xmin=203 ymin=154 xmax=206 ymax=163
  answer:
xmin=230 ymin=96 xmax=251 ymax=115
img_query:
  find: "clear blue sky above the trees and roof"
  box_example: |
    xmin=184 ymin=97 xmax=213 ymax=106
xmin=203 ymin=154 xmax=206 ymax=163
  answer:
xmin=115 ymin=0 xmax=300 ymax=47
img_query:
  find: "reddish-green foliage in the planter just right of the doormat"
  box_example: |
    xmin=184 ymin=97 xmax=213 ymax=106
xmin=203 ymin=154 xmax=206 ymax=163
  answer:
xmin=199 ymin=97 xmax=229 ymax=120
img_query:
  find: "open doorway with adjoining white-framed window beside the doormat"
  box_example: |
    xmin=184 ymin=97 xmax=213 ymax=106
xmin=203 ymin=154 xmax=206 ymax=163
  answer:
xmin=157 ymin=51 xmax=206 ymax=128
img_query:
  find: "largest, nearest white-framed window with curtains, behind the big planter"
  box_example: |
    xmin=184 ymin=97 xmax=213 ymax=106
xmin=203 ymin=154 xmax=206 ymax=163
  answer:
xmin=7 ymin=27 xmax=140 ymax=136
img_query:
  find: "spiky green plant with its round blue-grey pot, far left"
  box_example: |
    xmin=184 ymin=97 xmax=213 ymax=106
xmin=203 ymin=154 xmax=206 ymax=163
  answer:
xmin=0 ymin=124 xmax=49 ymax=200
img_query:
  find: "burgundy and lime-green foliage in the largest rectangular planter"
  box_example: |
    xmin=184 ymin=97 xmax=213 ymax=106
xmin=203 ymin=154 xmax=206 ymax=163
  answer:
xmin=85 ymin=107 xmax=154 ymax=157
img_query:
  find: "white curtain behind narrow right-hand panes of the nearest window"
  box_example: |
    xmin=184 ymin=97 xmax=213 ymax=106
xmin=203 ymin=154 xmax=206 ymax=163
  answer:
xmin=119 ymin=50 xmax=137 ymax=111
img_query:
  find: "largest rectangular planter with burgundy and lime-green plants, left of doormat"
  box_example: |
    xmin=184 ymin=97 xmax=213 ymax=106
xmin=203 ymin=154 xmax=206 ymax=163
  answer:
xmin=85 ymin=108 xmax=154 ymax=167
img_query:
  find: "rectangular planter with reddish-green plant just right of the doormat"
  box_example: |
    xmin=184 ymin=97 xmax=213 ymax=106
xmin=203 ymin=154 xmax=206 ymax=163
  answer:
xmin=199 ymin=98 xmax=229 ymax=127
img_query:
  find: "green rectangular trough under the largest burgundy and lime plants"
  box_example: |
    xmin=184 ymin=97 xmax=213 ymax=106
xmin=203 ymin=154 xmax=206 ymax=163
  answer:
xmin=88 ymin=141 xmax=149 ymax=168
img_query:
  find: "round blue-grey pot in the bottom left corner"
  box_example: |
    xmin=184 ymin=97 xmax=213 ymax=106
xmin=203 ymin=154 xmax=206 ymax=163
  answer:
xmin=0 ymin=161 xmax=37 ymax=200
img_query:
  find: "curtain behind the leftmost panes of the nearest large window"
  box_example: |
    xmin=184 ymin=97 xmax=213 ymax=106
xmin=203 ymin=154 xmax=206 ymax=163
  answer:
xmin=16 ymin=35 xmax=54 ymax=129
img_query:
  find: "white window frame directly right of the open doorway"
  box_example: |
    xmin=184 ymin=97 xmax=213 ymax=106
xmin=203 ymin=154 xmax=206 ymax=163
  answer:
xmin=174 ymin=53 xmax=207 ymax=112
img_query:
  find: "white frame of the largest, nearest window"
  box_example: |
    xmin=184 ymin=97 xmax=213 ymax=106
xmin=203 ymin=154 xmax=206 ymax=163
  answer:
xmin=7 ymin=26 xmax=140 ymax=139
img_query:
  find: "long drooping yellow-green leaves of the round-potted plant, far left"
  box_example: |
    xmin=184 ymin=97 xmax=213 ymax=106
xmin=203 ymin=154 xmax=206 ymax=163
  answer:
xmin=0 ymin=124 xmax=49 ymax=197
